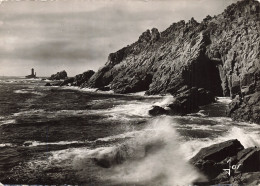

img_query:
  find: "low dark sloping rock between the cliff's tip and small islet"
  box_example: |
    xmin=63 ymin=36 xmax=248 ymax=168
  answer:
xmin=60 ymin=70 xmax=95 ymax=86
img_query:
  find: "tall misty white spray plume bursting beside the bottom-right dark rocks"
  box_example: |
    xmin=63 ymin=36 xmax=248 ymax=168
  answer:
xmin=90 ymin=117 xmax=205 ymax=185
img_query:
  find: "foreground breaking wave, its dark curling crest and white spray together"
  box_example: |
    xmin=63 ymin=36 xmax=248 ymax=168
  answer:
xmin=45 ymin=117 xmax=205 ymax=185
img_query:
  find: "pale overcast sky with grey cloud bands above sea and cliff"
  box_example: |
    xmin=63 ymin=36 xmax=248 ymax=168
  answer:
xmin=0 ymin=0 xmax=240 ymax=76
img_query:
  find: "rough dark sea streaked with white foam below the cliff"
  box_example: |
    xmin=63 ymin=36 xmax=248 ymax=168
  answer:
xmin=0 ymin=77 xmax=260 ymax=186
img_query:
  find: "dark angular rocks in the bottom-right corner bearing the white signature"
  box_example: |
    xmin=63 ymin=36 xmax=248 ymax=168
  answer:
xmin=190 ymin=140 xmax=260 ymax=185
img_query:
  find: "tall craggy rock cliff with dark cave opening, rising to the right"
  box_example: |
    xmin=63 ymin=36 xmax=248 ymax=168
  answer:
xmin=86 ymin=0 xmax=260 ymax=123
